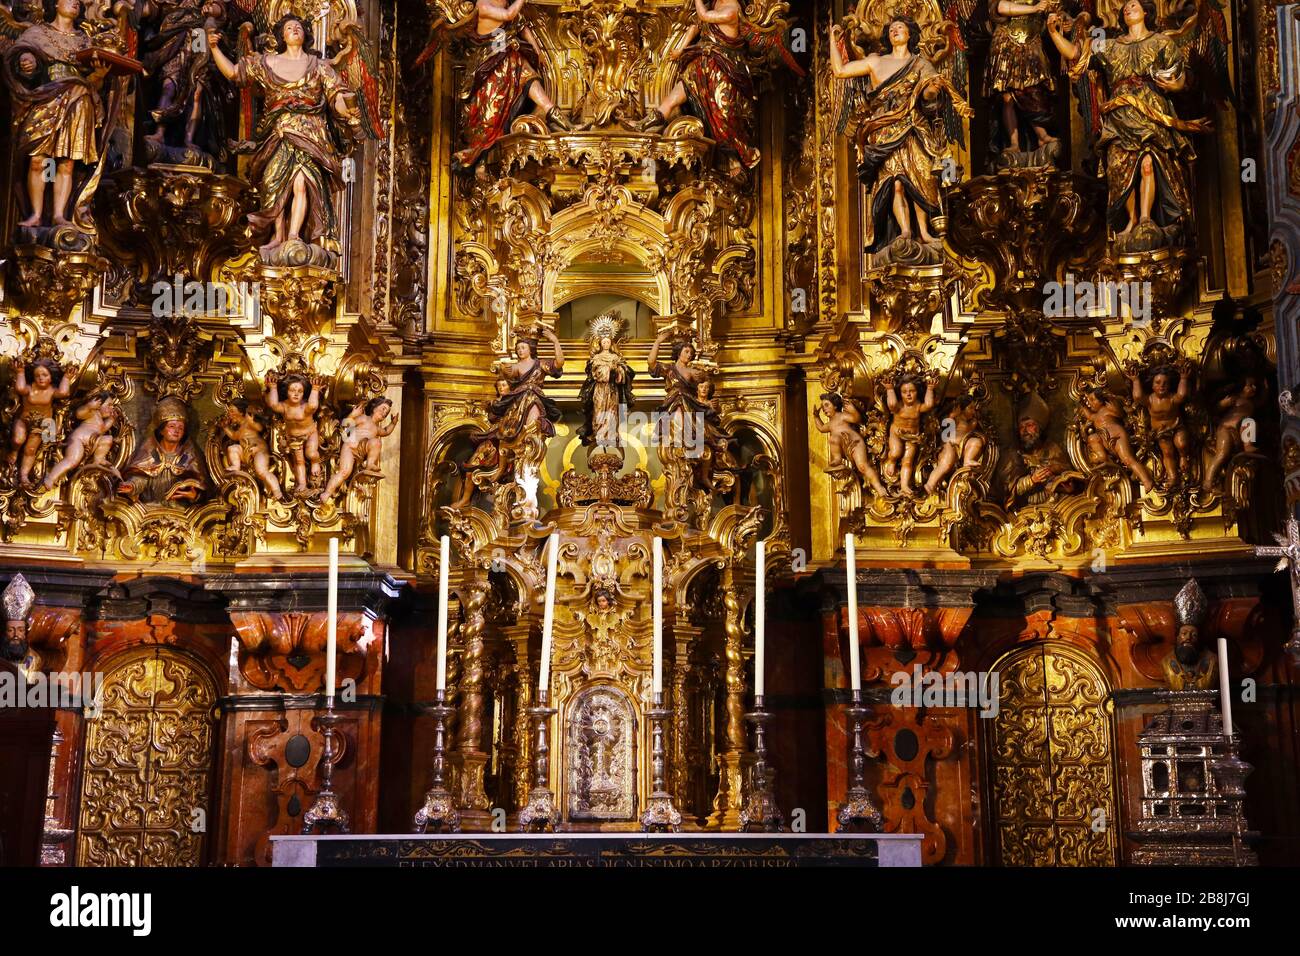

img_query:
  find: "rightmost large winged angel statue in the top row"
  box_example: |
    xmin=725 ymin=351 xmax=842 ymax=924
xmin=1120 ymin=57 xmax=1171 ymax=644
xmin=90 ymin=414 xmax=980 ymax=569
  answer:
xmin=1048 ymin=0 xmax=1234 ymax=252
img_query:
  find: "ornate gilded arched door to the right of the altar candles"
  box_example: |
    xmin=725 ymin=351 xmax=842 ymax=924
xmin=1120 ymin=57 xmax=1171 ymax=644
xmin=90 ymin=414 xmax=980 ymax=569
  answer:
xmin=989 ymin=644 xmax=1119 ymax=866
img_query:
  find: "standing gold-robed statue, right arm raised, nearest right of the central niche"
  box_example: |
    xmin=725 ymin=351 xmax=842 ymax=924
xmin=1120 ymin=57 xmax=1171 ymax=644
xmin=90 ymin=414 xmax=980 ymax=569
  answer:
xmin=831 ymin=17 xmax=971 ymax=263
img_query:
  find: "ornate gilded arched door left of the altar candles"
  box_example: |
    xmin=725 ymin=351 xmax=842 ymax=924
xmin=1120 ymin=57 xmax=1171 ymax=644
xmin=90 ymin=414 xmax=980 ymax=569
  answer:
xmin=78 ymin=648 xmax=216 ymax=866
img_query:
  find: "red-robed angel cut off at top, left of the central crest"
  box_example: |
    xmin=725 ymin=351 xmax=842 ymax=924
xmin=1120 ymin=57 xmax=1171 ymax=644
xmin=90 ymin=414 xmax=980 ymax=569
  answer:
xmin=415 ymin=0 xmax=571 ymax=168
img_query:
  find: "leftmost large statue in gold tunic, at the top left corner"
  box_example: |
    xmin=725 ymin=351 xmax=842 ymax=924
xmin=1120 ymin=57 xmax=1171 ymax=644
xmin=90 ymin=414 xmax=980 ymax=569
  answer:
xmin=0 ymin=0 xmax=139 ymax=241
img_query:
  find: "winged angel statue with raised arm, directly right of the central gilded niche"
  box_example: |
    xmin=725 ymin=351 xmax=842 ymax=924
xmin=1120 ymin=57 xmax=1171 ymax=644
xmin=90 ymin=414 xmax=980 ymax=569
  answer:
xmin=831 ymin=0 xmax=971 ymax=265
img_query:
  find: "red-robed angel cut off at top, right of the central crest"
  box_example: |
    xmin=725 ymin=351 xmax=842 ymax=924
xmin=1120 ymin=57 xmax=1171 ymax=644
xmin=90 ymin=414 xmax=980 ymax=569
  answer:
xmin=638 ymin=0 xmax=803 ymax=169
